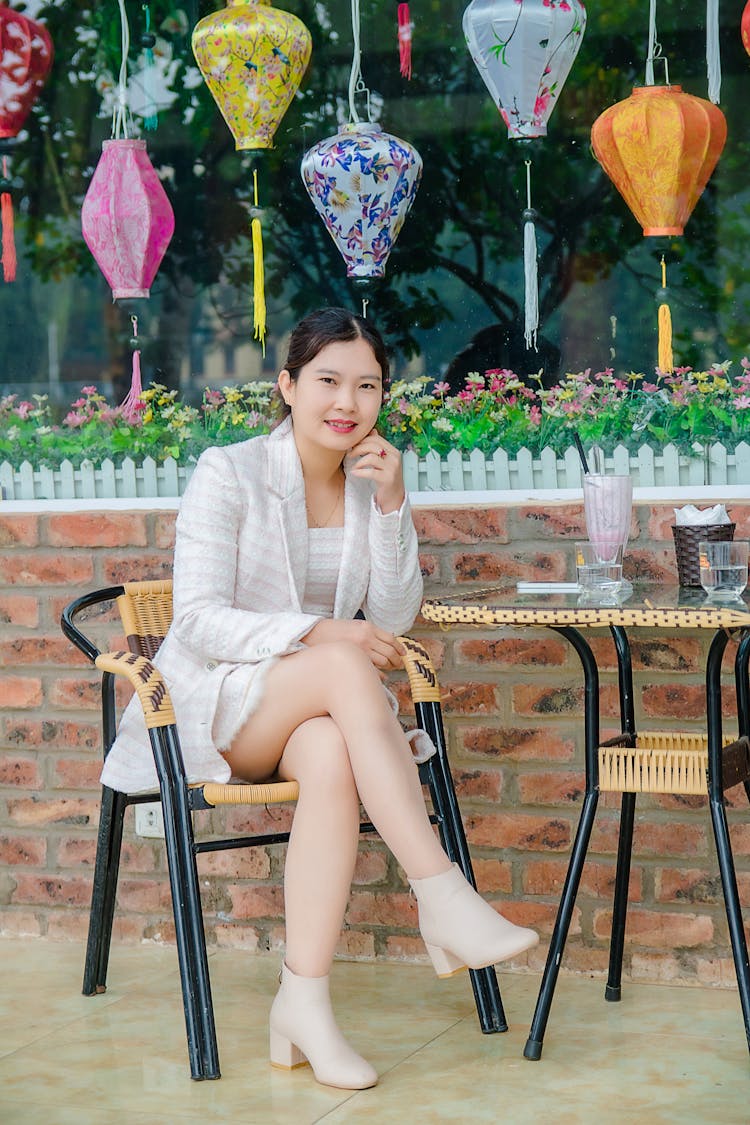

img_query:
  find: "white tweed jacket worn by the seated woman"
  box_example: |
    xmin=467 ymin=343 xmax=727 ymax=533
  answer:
xmin=101 ymin=420 xmax=422 ymax=793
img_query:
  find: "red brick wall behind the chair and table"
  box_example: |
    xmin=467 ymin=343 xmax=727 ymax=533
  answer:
xmin=0 ymin=502 xmax=750 ymax=983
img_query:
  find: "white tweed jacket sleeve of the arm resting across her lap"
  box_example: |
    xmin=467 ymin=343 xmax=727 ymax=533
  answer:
xmin=172 ymin=449 xmax=320 ymax=663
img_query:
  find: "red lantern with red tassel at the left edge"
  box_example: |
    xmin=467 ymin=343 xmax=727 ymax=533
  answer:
xmin=0 ymin=2 xmax=53 ymax=281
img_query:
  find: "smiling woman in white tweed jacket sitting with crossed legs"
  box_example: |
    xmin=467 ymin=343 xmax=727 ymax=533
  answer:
xmin=102 ymin=308 xmax=539 ymax=1089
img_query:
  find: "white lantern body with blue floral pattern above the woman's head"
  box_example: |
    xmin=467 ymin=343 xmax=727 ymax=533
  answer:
xmin=301 ymin=122 xmax=422 ymax=279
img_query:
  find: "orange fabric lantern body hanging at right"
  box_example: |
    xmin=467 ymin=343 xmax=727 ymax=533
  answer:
xmin=591 ymin=86 xmax=726 ymax=235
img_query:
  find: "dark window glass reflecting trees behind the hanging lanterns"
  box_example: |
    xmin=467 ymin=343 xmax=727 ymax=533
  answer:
xmin=0 ymin=0 xmax=750 ymax=414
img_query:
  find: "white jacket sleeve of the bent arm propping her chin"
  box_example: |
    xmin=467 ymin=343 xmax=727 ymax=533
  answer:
xmin=363 ymin=497 xmax=422 ymax=633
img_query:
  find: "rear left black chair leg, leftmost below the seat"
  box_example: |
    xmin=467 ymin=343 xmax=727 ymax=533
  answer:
xmin=83 ymin=785 xmax=129 ymax=996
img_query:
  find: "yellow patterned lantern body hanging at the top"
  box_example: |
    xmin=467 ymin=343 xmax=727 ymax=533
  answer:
xmin=192 ymin=0 xmax=313 ymax=150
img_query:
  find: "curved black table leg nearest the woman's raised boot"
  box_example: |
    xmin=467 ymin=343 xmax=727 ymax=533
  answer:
xmin=524 ymin=626 xmax=599 ymax=1061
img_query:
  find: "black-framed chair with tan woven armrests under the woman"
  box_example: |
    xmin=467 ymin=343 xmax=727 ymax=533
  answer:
xmin=61 ymin=582 xmax=507 ymax=1079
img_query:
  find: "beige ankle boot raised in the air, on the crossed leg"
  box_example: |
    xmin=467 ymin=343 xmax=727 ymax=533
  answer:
xmin=409 ymin=864 xmax=539 ymax=977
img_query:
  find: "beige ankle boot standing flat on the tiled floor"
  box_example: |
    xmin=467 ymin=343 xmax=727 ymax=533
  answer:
xmin=270 ymin=964 xmax=378 ymax=1090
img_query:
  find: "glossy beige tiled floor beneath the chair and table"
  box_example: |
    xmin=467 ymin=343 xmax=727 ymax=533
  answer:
xmin=0 ymin=941 xmax=750 ymax=1125
